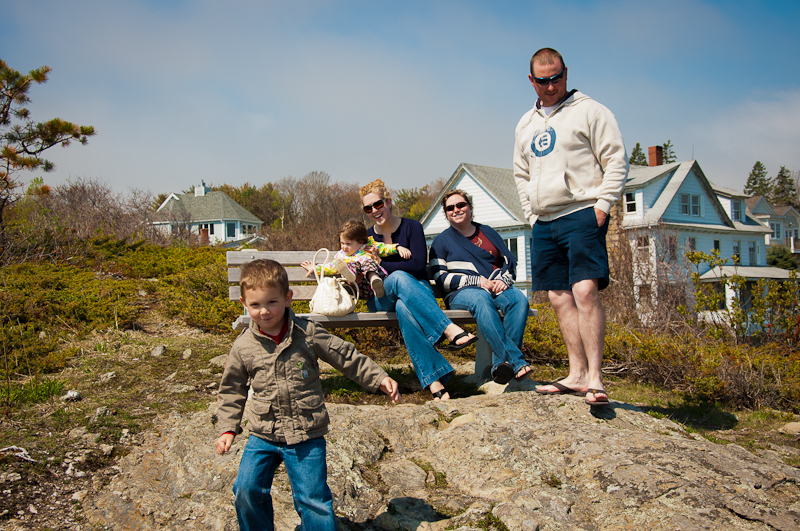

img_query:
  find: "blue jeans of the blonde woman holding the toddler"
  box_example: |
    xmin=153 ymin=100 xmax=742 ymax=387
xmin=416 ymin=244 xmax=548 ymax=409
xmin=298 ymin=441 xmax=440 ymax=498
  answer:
xmin=367 ymin=271 xmax=453 ymax=389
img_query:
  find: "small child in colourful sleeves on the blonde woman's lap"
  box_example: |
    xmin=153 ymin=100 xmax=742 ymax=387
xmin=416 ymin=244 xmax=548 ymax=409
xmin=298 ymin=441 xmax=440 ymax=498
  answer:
xmin=300 ymin=220 xmax=411 ymax=300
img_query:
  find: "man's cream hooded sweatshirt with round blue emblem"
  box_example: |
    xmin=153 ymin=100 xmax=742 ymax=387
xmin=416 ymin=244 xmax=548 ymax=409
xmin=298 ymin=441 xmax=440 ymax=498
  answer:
xmin=514 ymin=90 xmax=628 ymax=225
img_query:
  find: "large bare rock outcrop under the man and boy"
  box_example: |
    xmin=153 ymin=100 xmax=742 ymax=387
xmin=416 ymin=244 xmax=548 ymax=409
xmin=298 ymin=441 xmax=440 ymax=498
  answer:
xmin=84 ymin=392 xmax=800 ymax=531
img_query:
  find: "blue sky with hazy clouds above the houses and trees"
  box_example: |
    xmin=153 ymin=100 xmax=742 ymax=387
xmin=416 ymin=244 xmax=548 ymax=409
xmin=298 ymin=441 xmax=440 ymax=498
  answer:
xmin=0 ymin=0 xmax=800 ymax=194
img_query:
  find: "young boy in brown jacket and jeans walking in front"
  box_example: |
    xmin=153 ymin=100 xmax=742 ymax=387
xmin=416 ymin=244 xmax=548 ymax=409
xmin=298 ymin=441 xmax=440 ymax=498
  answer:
xmin=214 ymin=260 xmax=400 ymax=531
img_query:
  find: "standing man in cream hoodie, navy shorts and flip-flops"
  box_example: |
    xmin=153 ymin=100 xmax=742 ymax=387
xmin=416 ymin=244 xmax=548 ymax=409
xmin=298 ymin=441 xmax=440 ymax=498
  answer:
xmin=514 ymin=48 xmax=628 ymax=405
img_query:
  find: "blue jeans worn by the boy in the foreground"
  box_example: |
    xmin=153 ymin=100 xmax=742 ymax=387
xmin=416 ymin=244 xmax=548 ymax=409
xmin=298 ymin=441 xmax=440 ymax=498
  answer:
xmin=233 ymin=435 xmax=336 ymax=531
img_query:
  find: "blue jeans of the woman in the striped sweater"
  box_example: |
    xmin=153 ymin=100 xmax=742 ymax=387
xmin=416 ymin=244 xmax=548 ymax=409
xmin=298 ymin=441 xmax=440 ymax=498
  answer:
xmin=449 ymin=288 xmax=530 ymax=373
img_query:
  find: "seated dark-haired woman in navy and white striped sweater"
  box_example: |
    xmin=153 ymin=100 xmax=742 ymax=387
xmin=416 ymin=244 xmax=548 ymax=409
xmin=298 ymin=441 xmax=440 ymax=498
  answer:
xmin=429 ymin=190 xmax=531 ymax=384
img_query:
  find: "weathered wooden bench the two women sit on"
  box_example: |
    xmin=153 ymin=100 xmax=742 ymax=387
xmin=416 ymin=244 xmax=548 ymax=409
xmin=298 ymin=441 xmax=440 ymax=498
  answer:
xmin=227 ymin=250 xmax=538 ymax=385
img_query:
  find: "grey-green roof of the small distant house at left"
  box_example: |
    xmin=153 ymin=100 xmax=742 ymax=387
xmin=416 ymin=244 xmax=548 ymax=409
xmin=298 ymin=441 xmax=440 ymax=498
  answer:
xmin=155 ymin=192 xmax=263 ymax=225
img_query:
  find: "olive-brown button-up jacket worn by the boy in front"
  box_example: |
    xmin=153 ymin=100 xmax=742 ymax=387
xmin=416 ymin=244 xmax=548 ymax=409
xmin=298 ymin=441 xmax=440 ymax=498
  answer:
xmin=217 ymin=309 xmax=387 ymax=444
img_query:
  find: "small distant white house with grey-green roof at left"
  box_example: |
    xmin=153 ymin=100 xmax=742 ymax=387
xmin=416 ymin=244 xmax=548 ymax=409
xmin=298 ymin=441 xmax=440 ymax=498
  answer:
xmin=152 ymin=182 xmax=263 ymax=245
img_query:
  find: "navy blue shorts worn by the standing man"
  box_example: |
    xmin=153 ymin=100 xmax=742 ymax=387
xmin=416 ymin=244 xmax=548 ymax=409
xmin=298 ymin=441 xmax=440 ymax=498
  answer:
xmin=531 ymin=208 xmax=609 ymax=291
